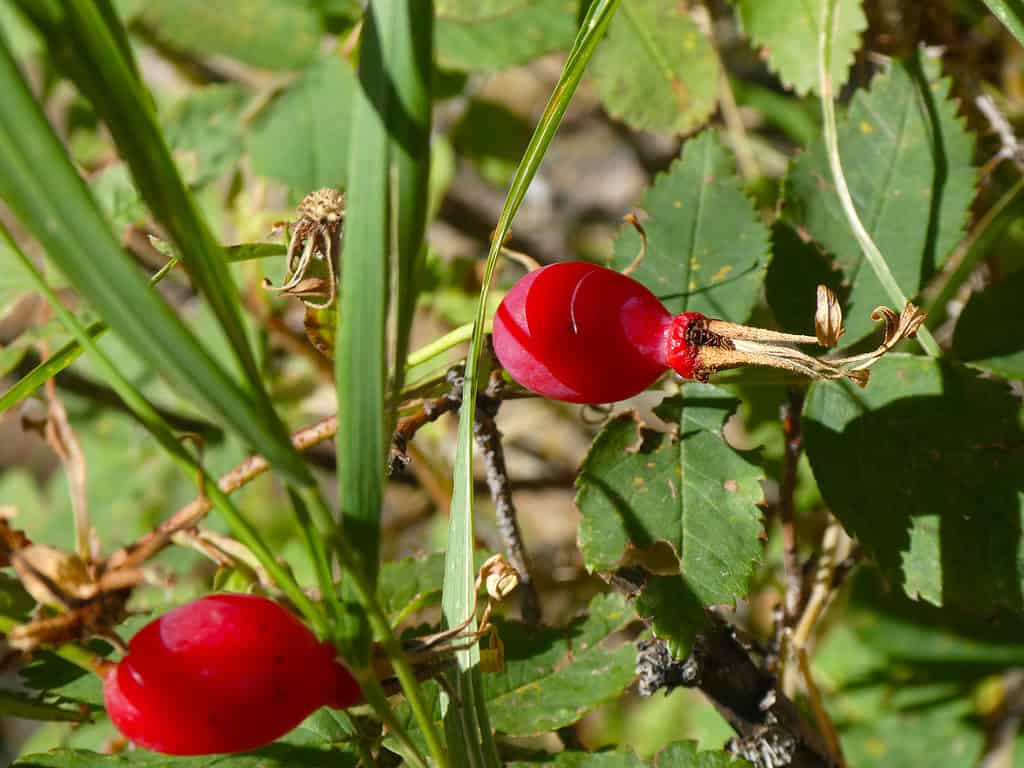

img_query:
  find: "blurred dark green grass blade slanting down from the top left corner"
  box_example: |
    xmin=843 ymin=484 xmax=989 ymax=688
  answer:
xmin=12 ymin=0 xmax=312 ymax=484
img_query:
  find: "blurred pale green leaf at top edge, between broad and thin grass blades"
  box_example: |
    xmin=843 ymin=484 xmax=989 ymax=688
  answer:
xmin=434 ymin=0 xmax=577 ymax=72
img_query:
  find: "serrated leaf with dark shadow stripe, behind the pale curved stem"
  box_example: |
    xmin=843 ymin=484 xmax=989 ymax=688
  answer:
xmin=783 ymin=55 xmax=976 ymax=343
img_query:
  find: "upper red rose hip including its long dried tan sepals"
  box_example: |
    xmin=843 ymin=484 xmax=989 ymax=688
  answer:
xmin=493 ymin=261 xmax=860 ymax=403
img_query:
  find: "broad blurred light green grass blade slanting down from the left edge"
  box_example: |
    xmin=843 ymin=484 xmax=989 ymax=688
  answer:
xmin=0 ymin=31 xmax=312 ymax=484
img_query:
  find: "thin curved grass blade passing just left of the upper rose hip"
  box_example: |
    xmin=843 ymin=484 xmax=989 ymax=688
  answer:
xmin=441 ymin=0 xmax=618 ymax=767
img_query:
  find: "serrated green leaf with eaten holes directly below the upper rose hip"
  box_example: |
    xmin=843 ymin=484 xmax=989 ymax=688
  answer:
xmin=577 ymin=384 xmax=763 ymax=605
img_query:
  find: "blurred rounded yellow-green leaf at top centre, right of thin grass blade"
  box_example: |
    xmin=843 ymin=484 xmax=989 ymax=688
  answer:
xmin=593 ymin=0 xmax=721 ymax=133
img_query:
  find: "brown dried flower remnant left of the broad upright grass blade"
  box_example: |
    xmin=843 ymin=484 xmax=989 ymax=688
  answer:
xmin=264 ymin=187 xmax=345 ymax=309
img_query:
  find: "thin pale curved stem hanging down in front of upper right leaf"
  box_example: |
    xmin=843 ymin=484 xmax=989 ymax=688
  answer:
xmin=818 ymin=0 xmax=941 ymax=357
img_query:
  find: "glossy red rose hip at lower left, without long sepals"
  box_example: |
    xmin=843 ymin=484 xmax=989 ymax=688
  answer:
xmin=103 ymin=594 xmax=362 ymax=755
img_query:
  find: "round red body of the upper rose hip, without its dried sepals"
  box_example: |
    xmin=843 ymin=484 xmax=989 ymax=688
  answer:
xmin=494 ymin=261 xmax=672 ymax=402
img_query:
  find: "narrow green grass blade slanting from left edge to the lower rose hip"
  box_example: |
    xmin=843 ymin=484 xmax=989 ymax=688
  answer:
xmin=0 ymin=222 xmax=328 ymax=637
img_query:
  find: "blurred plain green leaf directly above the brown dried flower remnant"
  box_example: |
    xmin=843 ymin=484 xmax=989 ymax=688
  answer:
xmin=247 ymin=56 xmax=356 ymax=200
